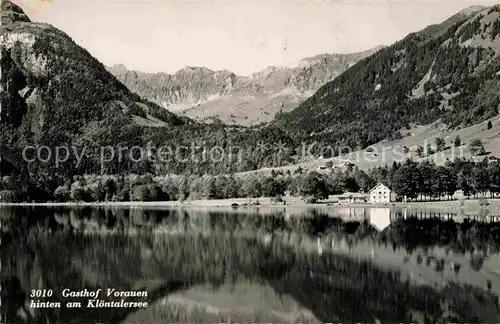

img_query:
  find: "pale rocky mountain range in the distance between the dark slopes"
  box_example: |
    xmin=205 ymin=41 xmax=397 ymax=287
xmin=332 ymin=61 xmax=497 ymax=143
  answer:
xmin=108 ymin=47 xmax=380 ymax=125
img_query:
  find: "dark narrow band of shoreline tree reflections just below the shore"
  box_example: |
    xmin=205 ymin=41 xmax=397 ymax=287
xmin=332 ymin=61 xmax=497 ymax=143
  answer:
xmin=2 ymin=207 xmax=500 ymax=254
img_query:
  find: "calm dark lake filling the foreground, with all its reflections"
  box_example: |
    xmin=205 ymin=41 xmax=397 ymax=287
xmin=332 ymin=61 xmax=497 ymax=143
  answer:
xmin=0 ymin=206 xmax=500 ymax=323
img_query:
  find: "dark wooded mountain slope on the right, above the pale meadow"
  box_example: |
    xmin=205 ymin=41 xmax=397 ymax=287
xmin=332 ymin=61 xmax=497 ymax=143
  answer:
xmin=273 ymin=6 xmax=500 ymax=156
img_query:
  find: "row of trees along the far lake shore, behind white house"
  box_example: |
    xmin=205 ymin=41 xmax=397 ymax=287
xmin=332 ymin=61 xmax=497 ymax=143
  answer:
xmin=0 ymin=159 xmax=500 ymax=204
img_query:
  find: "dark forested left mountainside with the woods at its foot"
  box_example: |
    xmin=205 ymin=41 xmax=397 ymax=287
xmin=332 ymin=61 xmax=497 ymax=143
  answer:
xmin=0 ymin=1 xmax=293 ymax=199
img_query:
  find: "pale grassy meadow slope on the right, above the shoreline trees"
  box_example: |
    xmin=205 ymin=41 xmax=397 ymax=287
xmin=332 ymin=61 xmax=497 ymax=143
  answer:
xmin=237 ymin=115 xmax=500 ymax=177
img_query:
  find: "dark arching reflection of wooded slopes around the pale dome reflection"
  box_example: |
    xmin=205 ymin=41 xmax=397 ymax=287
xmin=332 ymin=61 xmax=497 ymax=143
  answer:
xmin=3 ymin=230 xmax=498 ymax=323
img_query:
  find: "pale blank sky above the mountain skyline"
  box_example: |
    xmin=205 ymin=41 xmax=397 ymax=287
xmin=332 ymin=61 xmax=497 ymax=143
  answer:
xmin=14 ymin=0 xmax=499 ymax=75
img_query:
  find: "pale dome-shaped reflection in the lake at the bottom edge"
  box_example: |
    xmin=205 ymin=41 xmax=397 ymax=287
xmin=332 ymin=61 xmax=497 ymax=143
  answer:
xmin=124 ymin=281 xmax=320 ymax=323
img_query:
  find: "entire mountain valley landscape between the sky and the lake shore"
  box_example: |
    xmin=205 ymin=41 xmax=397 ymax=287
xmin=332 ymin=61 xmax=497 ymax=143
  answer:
xmin=0 ymin=1 xmax=500 ymax=205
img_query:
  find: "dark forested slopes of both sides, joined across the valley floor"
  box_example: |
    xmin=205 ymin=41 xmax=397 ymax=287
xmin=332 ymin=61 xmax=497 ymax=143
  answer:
xmin=0 ymin=1 xmax=500 ymax=201
